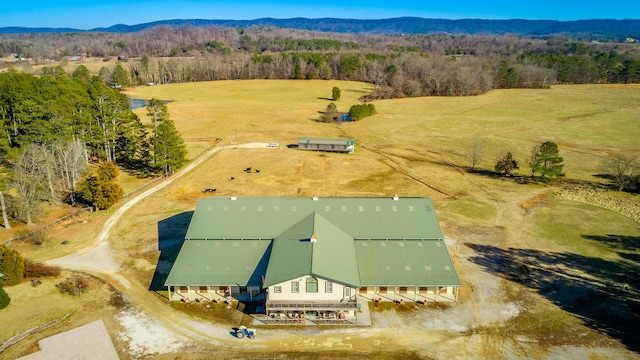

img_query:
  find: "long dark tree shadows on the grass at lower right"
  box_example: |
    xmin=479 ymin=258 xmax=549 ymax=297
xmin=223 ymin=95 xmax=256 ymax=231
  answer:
xmin=465 ymin=243 xmax=640 ymax=351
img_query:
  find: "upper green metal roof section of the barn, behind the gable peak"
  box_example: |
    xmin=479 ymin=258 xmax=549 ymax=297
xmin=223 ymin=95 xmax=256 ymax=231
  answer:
xmin=185 ymin=197 xmax=442 ymax=240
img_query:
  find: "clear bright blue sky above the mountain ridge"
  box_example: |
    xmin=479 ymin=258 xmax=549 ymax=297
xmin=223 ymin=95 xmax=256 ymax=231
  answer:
xmin=0 ymin=0 xmax=640 ymax=29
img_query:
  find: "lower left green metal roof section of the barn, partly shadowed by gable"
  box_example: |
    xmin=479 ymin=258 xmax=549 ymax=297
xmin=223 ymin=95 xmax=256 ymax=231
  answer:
xmin=165 ymin=240 xmax=271 ymax=286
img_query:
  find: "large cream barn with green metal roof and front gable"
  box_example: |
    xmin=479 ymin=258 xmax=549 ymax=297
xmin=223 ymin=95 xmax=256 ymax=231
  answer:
xmin=165 ymin=196 xmax=461 ymax=321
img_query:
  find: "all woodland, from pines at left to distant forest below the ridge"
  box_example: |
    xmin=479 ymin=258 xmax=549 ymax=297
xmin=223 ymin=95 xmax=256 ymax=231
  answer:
xmin=0 ymin=25 xmax=640 ymax=227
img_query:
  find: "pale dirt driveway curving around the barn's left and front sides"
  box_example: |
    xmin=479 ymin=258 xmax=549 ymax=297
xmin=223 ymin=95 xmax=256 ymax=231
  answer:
xmin=49 ymin=144 xmax=634 ymax=359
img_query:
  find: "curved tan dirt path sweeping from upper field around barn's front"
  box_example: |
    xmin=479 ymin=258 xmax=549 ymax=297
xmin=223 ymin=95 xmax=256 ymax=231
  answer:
xmin=43 ymin=143 xmax=626 ymax=358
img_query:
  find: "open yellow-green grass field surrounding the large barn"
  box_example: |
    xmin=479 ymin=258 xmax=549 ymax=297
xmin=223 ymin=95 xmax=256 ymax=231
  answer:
xmin=4 ymin=80 xmax=640 ymax=359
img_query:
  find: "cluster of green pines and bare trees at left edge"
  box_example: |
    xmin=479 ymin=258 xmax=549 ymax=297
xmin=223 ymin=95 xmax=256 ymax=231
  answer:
xmin=0 ymin=66 xmax=186 ymax=228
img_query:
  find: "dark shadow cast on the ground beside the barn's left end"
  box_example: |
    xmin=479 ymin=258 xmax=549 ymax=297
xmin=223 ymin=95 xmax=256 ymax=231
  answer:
xmin=149 ymin=211 xmax=193 ymax=291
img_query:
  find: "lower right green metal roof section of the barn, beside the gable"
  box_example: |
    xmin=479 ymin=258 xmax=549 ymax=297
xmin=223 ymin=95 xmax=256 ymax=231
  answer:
xmin=355 ymin=239 xmax=461 ymax=286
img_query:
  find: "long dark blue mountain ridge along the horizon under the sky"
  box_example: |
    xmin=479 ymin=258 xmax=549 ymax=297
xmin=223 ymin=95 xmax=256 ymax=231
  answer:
xmin=0 ymin=17 xmax=640 ymax=38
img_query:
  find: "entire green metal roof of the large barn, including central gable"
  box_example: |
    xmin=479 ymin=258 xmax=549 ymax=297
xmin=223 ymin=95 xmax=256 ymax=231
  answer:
xmin=165 ymin=197 xmax=460 ymax=287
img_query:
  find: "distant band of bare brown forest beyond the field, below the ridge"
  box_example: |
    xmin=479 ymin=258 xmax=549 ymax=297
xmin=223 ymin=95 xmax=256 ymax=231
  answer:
xmin=0 ymin=25 xmax=640 ymax=98
